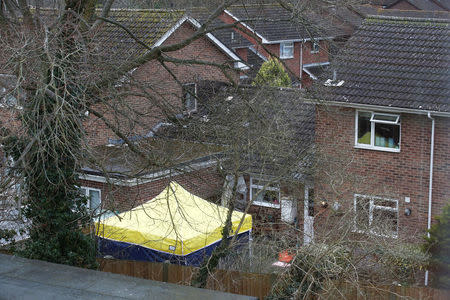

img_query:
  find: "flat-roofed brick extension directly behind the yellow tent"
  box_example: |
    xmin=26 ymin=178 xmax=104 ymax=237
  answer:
xmin=80 ymin=138 xmax=223 ymax=215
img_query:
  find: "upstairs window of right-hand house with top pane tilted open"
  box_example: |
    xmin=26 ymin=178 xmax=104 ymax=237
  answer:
xmin=355 ymin=111 xmax=400 ymax=152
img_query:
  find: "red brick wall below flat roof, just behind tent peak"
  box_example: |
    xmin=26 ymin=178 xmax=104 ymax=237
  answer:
xmin=80 ymin=166 xmax=223 ymax=211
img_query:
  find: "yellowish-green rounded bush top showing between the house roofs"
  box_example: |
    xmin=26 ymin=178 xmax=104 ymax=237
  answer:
xmin=252 ymin=58 xmax=291 ymax=87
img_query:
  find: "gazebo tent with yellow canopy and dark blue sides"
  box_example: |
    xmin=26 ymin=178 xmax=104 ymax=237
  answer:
xmin=95 ymin=182 xmax=252 ymax=265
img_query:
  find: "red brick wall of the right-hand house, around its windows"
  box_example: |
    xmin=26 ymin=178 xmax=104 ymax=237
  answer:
xmin=315 ymin=107 xmax=450 ymax=239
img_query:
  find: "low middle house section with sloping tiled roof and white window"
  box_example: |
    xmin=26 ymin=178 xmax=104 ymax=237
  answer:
xmin=149 ymin=86 xmax=315 ymax=237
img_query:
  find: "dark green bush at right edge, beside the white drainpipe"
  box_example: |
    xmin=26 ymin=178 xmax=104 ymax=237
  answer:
xmin=423 ymin=204 xmax=450 ymax=289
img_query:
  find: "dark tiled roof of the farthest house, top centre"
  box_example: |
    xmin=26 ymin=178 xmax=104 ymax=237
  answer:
xmin=227 ymin=4 xmax=340 ymax=42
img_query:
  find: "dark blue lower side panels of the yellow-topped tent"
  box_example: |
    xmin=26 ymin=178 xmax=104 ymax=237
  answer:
xmin=97 ymin=231 xmax=250 ymax=266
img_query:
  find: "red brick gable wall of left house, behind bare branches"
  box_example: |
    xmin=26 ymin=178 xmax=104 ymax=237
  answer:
xmin=85 ymin=23 xmax=239 ymax=145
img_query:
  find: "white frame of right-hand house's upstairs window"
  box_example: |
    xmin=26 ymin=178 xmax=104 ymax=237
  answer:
xmin=355 ymin=110 xmax=402 ymax=152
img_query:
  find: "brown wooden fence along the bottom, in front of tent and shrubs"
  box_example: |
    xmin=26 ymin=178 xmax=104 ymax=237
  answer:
xmin=98 ymin=259 xmax=450 ymax=300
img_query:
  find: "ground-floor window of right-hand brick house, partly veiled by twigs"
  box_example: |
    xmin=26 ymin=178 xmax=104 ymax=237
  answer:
xmin=354 ymin=194 xmax=398 ymax=237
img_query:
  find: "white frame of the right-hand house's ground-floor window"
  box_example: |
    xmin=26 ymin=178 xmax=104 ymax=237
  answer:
xmin=353 ymin=194 xmax=400 ymax=238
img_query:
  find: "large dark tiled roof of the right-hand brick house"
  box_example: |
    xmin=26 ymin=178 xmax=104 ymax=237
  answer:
xmin=314 ymin=16 xmax=450 ymax=112
